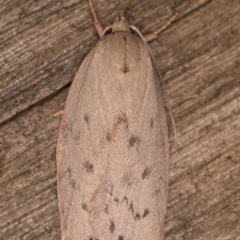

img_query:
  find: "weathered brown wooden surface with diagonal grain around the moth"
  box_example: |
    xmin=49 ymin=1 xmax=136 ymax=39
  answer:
xmin=0 ymin=0 xmax=240 ymax=240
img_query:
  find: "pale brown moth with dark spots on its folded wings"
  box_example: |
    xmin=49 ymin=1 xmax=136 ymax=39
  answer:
xmin=57 ymin=1 xmax=176 ymax=240
